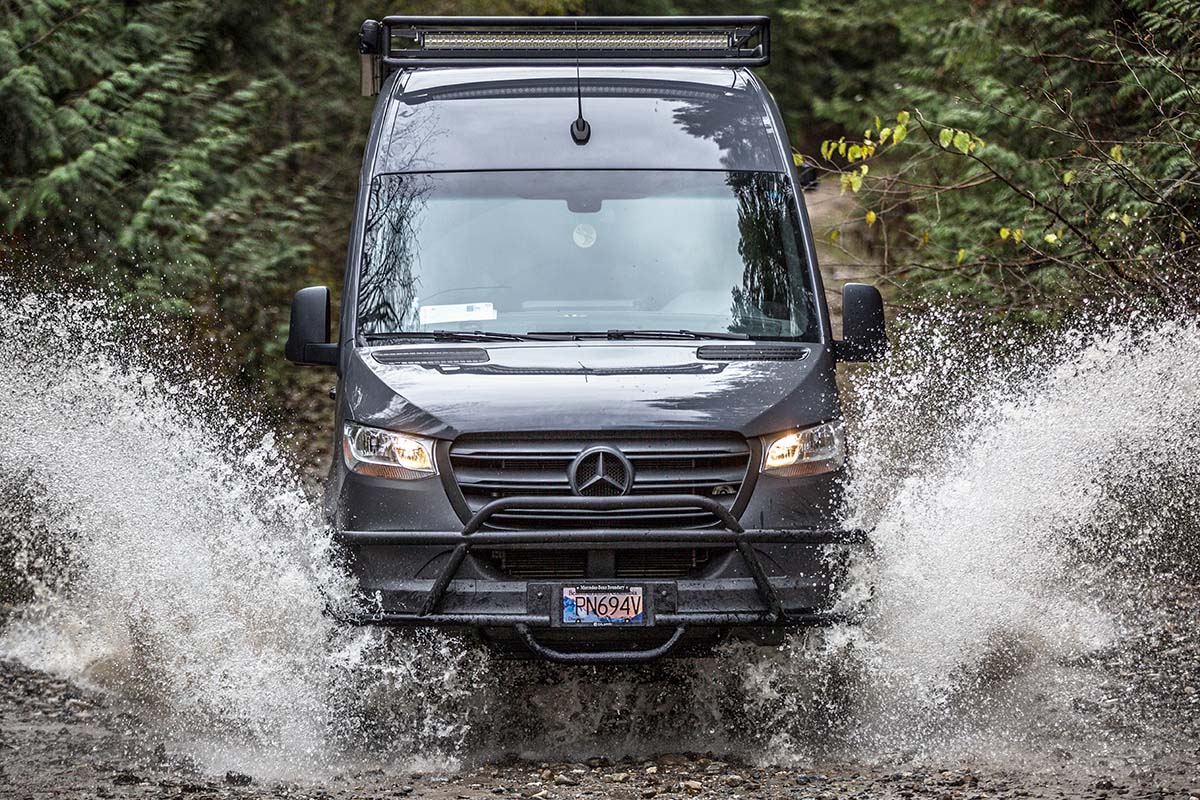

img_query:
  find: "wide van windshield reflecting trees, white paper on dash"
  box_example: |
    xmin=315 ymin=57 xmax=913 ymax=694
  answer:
xmin=356 ymin=170 xmax=817 ymax=341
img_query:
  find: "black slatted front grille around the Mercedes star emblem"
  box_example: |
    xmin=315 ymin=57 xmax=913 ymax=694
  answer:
xmin=450 ymin=433 xmax=750 ymax=530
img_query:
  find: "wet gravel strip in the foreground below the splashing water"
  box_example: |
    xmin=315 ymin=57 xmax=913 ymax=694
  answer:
xmin=0 ymin=661 xmax=1200 ymax=800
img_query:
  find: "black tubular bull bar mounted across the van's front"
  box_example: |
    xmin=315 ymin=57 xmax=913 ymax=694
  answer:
xmin=338 ymin=494 xmax=868 ymax=663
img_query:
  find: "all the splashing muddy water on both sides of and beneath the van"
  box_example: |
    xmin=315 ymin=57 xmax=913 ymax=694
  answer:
xmin=0 ymin=292 xmax=1200 ymax=780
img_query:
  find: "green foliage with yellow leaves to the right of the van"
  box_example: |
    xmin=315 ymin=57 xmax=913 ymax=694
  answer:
xmin=821 ymin=0 xmax=1200 ymax=319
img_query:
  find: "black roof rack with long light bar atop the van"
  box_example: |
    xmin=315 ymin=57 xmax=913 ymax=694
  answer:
xmin=359 ymin=17 xmax=770 ymax=95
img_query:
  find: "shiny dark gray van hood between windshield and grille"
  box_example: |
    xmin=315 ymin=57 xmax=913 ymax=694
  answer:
xmin=342 ymin=341 xmax=839 ymax=439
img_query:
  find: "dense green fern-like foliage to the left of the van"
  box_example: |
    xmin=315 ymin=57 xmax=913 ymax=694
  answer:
xmin=0 ymin=0 xmax=333 ymax=417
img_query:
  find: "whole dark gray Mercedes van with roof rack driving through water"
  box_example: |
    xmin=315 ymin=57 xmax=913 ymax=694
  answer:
xmin=287 ymin=17 xmax=886 ymax=662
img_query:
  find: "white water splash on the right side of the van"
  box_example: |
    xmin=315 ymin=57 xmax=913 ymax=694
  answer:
xmin=729 ymin=314 xmax=1200 ymax=768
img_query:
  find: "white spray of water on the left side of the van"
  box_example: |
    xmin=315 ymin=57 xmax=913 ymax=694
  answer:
xmin=0 ymin=297 xmax=355 ymax=772
